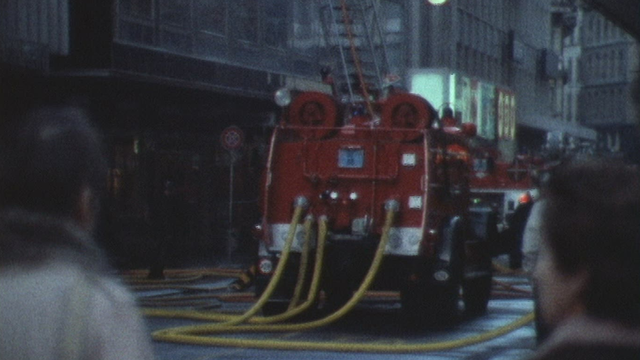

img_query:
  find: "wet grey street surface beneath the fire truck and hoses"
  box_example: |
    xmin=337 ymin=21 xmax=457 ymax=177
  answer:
xmin=125 ymin=270 xmax=535 ymax=360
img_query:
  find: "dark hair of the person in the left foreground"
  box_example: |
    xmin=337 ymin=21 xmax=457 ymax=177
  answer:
xmin=0 ymin=107 xmax=106 ymax=216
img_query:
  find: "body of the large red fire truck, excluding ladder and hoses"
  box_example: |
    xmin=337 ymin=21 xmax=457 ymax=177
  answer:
xmin=256 ymin=88 xmax=492 ymax=323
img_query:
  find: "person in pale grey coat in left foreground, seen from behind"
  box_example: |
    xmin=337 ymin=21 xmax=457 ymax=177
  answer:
xmin=0 ymin=108 xmax=153 ymax=360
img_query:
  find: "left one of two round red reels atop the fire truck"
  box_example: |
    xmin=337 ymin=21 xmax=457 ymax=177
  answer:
xmin=289 ymin=91 xmax=338 ymax=139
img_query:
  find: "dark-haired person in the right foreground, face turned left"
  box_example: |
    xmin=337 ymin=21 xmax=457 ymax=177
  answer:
xmin=532 ymin=160 xmax=640 ymax=360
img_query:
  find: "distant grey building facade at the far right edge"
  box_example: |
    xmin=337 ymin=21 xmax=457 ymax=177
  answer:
xmin=577 ymin=7 xmax=640 ymax=156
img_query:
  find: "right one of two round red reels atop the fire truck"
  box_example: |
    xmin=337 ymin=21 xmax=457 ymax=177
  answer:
xmin=381 ymin=93 xmax=432 ymax=141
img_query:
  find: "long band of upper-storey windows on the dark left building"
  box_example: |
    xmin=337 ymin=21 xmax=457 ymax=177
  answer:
xmin=114 ymin=0 xmax=406 ymax=83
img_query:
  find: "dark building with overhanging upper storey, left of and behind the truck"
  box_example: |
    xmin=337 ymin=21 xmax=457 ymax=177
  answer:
xmin=0 ymin=0 xmax=407 ymax=267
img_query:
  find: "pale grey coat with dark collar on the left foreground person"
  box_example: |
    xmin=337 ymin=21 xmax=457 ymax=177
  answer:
xmin=0 ymin=211 xmax=153 ymax=360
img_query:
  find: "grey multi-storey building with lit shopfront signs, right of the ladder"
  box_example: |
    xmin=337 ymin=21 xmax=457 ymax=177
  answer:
xmin=410 ymin=0 xmax=596 ymax=161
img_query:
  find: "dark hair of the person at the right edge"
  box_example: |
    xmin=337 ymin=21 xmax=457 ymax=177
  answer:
xmin=542 ymin=160 xmax=640 ymax=324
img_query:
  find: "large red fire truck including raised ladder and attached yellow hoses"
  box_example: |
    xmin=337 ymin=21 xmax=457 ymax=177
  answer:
xmin=250 ymin=0 xmax=492 ymax=325
